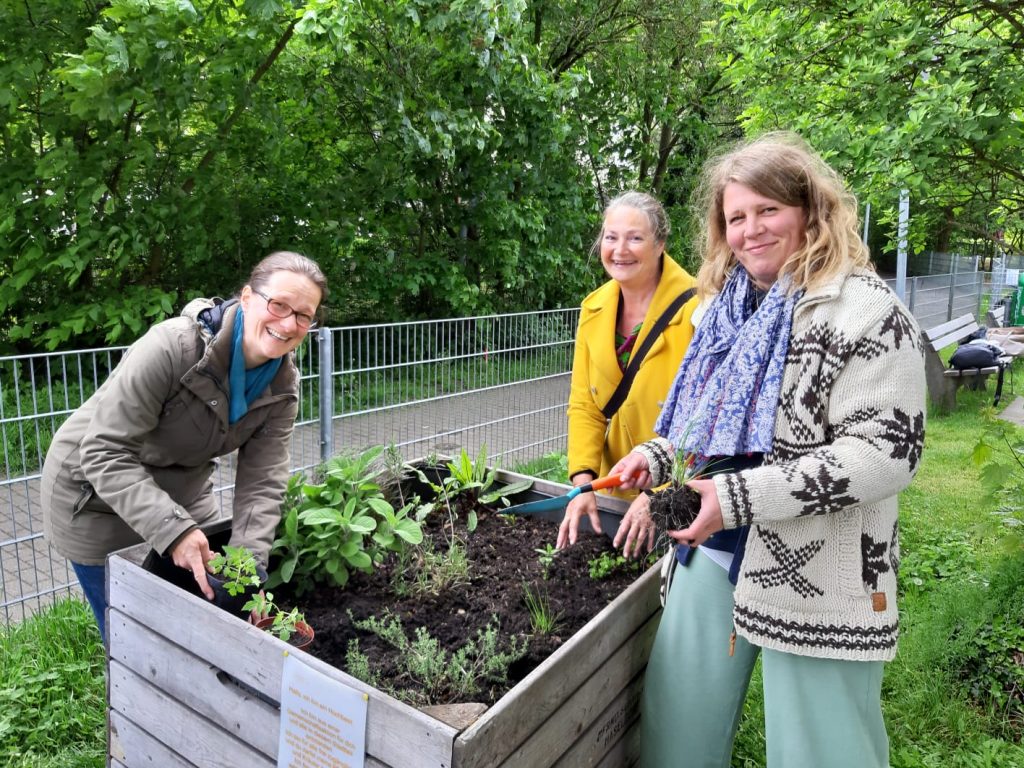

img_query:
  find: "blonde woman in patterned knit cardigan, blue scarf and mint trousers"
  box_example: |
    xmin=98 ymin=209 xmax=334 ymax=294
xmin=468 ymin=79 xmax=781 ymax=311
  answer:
xmin=611 ymin=134 xmax=925 ymax=768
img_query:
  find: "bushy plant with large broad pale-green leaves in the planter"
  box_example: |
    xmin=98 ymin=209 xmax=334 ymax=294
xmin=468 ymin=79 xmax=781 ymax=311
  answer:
xmin=267 ymin=446 xmax=423 ymax=594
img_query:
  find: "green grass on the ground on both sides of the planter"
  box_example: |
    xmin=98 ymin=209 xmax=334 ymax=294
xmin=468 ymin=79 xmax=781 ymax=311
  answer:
xmin=0 ymin=382 xmax=1024 ymax=768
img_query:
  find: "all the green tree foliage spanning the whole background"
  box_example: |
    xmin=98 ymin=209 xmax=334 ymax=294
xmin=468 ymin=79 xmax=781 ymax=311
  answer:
xmin=9 ymin=0 xmax=1024 ymax=351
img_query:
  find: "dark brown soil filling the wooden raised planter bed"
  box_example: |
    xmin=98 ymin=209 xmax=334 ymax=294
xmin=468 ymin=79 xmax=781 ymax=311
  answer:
xmin=274 ymin=505 xmax=641 ymax=705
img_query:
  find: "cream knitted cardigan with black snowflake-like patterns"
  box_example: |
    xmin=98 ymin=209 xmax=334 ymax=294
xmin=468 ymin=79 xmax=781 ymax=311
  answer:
xmin=637 ymin=270 xmax=925 ymax=660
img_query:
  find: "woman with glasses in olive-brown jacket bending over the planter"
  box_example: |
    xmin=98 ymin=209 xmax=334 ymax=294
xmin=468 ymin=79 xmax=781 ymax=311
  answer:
xmin=42 ymin=251 xmax=327 ymax=638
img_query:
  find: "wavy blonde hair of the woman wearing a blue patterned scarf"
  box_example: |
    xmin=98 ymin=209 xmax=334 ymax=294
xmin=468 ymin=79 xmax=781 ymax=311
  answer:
xmin=694 ymin=131 xmax=871 ymax=296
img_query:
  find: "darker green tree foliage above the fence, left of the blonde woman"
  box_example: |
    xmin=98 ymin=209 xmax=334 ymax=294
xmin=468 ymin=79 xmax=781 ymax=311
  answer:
xmin=0 ymin=0 xmax=733 ymax=349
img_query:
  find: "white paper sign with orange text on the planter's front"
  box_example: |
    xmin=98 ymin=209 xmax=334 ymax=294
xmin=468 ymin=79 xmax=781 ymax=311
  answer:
xmin=278 ymin=653 xmax=368 ymax=768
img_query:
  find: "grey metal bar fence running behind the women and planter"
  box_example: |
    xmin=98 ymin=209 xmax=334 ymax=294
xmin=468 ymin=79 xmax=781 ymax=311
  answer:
xmin=0 ymin=271 xmax=1010 ymax=623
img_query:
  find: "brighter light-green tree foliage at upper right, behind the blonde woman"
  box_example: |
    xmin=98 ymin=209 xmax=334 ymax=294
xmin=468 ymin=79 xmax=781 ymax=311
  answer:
xmin=715 ymin=0 xmax=1024 ymax=259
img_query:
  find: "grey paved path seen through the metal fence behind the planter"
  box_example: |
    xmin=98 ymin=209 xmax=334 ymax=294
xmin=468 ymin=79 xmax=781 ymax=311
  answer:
xmin=0 ymin=374 xmax=568 ymax=624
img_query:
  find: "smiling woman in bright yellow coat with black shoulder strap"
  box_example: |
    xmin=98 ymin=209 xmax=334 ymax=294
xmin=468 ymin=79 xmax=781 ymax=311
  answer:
xmin=558 ymin=191 xmax=697 ymax=548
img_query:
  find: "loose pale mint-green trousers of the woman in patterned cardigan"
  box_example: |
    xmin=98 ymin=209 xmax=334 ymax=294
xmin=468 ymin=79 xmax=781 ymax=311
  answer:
xmin=640 ymin=552 xmax=889 ymax=768
